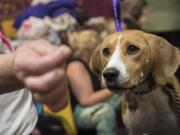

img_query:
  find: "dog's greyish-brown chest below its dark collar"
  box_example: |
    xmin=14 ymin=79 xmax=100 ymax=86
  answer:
xmin=122 ymin=89 xmax=180 ymax=135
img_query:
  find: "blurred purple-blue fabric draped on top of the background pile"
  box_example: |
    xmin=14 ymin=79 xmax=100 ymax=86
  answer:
xmin=14 ymin=0 xmax=78 ymax=29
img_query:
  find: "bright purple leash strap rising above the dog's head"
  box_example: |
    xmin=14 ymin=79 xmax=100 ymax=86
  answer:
xmin=112 ymin=0 xmax=122 ymax=32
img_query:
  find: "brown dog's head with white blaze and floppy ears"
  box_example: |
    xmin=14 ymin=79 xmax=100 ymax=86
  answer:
xmin=90 ymin=30 xmax=180 ymax=90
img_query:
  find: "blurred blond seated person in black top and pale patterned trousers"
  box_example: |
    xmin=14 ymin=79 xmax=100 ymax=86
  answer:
xmin=67 ymin=30 xmax=119 ymax=135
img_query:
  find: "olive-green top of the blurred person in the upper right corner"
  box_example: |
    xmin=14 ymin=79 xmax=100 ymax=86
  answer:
xmin=142 ymin=0 xmax=180 ymax=32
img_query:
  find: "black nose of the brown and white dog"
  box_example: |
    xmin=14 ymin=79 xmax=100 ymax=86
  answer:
xmin=103 ymin=68 xmax=119 ymax=83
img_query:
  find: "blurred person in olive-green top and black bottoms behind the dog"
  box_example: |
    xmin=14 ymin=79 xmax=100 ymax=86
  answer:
xmin=137 ymin=0 xmax=180 ymax=47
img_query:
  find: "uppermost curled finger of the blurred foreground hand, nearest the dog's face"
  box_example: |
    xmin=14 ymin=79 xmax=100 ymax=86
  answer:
xmin=19 ymin=46 xmax=71 ymax=74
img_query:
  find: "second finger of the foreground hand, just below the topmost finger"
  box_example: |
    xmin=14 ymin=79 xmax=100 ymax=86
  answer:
xmin=25 ymin=69 xmax=66 ymax=94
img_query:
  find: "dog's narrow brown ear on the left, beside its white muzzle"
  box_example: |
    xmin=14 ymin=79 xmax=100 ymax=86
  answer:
xmin=90 ymin=44 xmax=103 ymax=77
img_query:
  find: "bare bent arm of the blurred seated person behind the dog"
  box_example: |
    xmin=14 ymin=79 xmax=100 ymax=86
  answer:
xmin=67 ymin=62 xmax=112 ymax=106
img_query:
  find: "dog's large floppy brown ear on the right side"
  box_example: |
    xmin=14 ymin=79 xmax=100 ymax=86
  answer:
xmin=146 ymin=35 xmax=180 ymax=86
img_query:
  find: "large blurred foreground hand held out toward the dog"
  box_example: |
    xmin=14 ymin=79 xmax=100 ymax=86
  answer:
xmin=13 ymin=40 xmax=71 ymax=111
